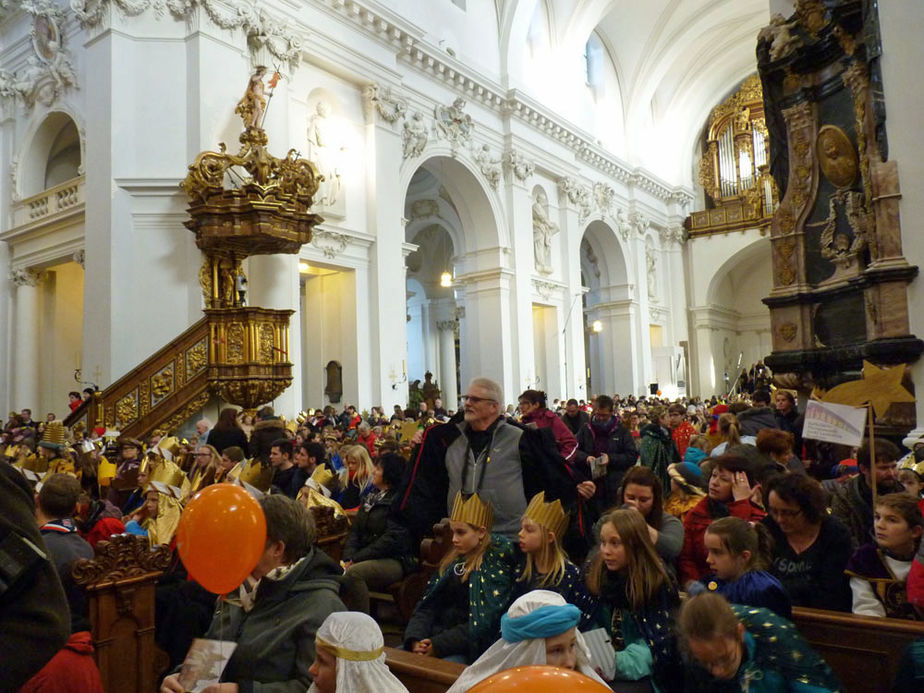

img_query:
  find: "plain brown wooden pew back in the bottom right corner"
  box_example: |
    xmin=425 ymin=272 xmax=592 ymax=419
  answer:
xmin=792 ymin=607 xmax=924 ymax=693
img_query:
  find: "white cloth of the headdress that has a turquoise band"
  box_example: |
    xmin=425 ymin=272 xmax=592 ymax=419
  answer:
xmin=447 ymin=590 xmax=606 ymax=693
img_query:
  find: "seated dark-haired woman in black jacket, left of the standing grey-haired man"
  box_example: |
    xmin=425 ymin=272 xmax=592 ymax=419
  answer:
xmin=343 ymin=453 xmax=414 ymax=591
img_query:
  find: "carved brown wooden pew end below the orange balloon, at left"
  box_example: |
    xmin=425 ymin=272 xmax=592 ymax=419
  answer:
xmin=72 ymin=534 xmax=170 ymax=693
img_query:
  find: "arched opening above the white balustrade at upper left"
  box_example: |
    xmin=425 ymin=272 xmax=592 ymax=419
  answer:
xmin=14 ymin=110 xmax=85 ymax=199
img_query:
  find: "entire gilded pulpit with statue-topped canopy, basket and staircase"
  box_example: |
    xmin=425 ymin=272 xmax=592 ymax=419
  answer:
xmin=65 ymin=71 xmax=323 ymax=438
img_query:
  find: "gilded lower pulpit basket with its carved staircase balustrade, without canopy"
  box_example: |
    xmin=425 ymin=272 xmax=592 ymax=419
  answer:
xmin=65 ymin=307 xmax=292 ymax=438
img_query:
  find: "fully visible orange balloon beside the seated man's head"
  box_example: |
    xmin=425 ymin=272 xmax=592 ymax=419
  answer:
xmin=176 ymin=484 xmax=266 ymax=594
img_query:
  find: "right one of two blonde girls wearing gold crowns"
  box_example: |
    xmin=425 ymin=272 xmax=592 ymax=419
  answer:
xmin=513 ymin=491 xmax=597 ymax=626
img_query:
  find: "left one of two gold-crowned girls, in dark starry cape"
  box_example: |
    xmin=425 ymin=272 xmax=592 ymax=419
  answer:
xmin=404 ymin=493 xmax=515 ymax=663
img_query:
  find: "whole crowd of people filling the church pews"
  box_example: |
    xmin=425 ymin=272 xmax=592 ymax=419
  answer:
xmin=0 ymin=378 xmax=924 ymax=693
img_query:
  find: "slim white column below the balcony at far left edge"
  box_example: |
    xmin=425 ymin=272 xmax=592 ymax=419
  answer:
xmin=10 ymin=269 xmax=44 ymax=410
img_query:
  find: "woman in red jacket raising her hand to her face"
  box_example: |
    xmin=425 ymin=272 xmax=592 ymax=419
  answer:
xmin=677 ymin=455 xmax=767 ymax=586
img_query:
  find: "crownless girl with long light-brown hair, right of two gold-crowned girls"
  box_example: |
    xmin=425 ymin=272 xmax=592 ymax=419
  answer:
xmin=587 ymin=508 xmax=680 ymax=690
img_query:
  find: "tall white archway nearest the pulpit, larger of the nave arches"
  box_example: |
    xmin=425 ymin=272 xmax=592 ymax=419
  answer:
xmin=404 ymin=155 xmax=513 ymax=400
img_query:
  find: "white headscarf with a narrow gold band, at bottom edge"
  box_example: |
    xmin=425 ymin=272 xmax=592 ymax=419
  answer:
xmin=308 ymin=611 xmax=408 ymax=693
